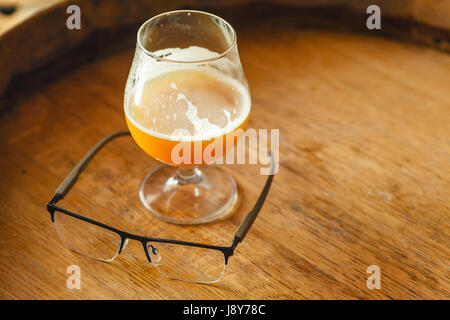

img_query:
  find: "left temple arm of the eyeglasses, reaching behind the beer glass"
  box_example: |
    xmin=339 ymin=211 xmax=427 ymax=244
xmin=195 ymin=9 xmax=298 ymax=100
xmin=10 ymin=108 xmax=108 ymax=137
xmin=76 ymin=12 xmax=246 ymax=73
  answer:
xmin=51 ymin=131 xmax=130 ymax=204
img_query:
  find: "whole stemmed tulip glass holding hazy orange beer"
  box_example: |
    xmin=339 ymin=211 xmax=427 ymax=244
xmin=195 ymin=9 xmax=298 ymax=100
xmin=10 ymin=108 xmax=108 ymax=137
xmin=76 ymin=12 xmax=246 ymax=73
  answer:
xmin=124 ymin=10 xmax=251 ymax=224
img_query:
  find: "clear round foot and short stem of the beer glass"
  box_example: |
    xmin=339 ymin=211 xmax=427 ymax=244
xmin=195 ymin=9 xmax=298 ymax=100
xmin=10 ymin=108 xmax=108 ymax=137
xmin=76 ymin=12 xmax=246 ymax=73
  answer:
xmin=139 ymin=165 xmax=239 ymax=225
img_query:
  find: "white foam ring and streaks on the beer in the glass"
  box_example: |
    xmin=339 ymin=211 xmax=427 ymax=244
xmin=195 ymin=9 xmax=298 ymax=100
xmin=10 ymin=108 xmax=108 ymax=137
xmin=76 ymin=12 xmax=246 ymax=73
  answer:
xmin=125 ymin=46 xmax=251 ymax=141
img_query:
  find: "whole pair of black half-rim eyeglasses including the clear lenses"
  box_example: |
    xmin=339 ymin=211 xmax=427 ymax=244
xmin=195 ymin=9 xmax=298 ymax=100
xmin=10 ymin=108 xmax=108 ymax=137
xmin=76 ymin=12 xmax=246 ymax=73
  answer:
xmin=47 ymin=131 xmax=274 ymax=283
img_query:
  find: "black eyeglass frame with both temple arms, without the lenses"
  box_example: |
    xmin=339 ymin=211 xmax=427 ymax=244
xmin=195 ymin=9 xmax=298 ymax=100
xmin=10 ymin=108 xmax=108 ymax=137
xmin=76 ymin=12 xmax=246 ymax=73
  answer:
xmin=47 ymin=131 xmax=274 ymax=265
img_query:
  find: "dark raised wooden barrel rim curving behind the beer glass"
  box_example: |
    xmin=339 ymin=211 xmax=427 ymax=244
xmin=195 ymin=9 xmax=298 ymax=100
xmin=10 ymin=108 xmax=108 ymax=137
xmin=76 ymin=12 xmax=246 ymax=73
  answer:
xmin=0 ymin=0 xmax=450 ymax=97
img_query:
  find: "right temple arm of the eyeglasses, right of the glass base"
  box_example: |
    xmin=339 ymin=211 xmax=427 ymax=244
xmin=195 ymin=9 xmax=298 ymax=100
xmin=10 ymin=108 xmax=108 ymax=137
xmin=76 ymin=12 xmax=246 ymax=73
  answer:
xmin=231 ymin=154 xmax=275 ymax=249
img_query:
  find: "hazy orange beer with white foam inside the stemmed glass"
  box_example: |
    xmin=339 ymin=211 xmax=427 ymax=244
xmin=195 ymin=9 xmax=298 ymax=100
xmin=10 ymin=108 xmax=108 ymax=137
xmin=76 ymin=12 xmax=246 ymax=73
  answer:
xmin=125 ymin=68 xmax=250 ymax=165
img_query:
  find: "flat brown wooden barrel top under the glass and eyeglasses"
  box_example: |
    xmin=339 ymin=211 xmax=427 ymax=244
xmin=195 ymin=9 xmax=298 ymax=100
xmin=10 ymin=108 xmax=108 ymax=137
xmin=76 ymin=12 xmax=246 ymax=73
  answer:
xmin=0 ymin=5 xmax=450 ymax=299
